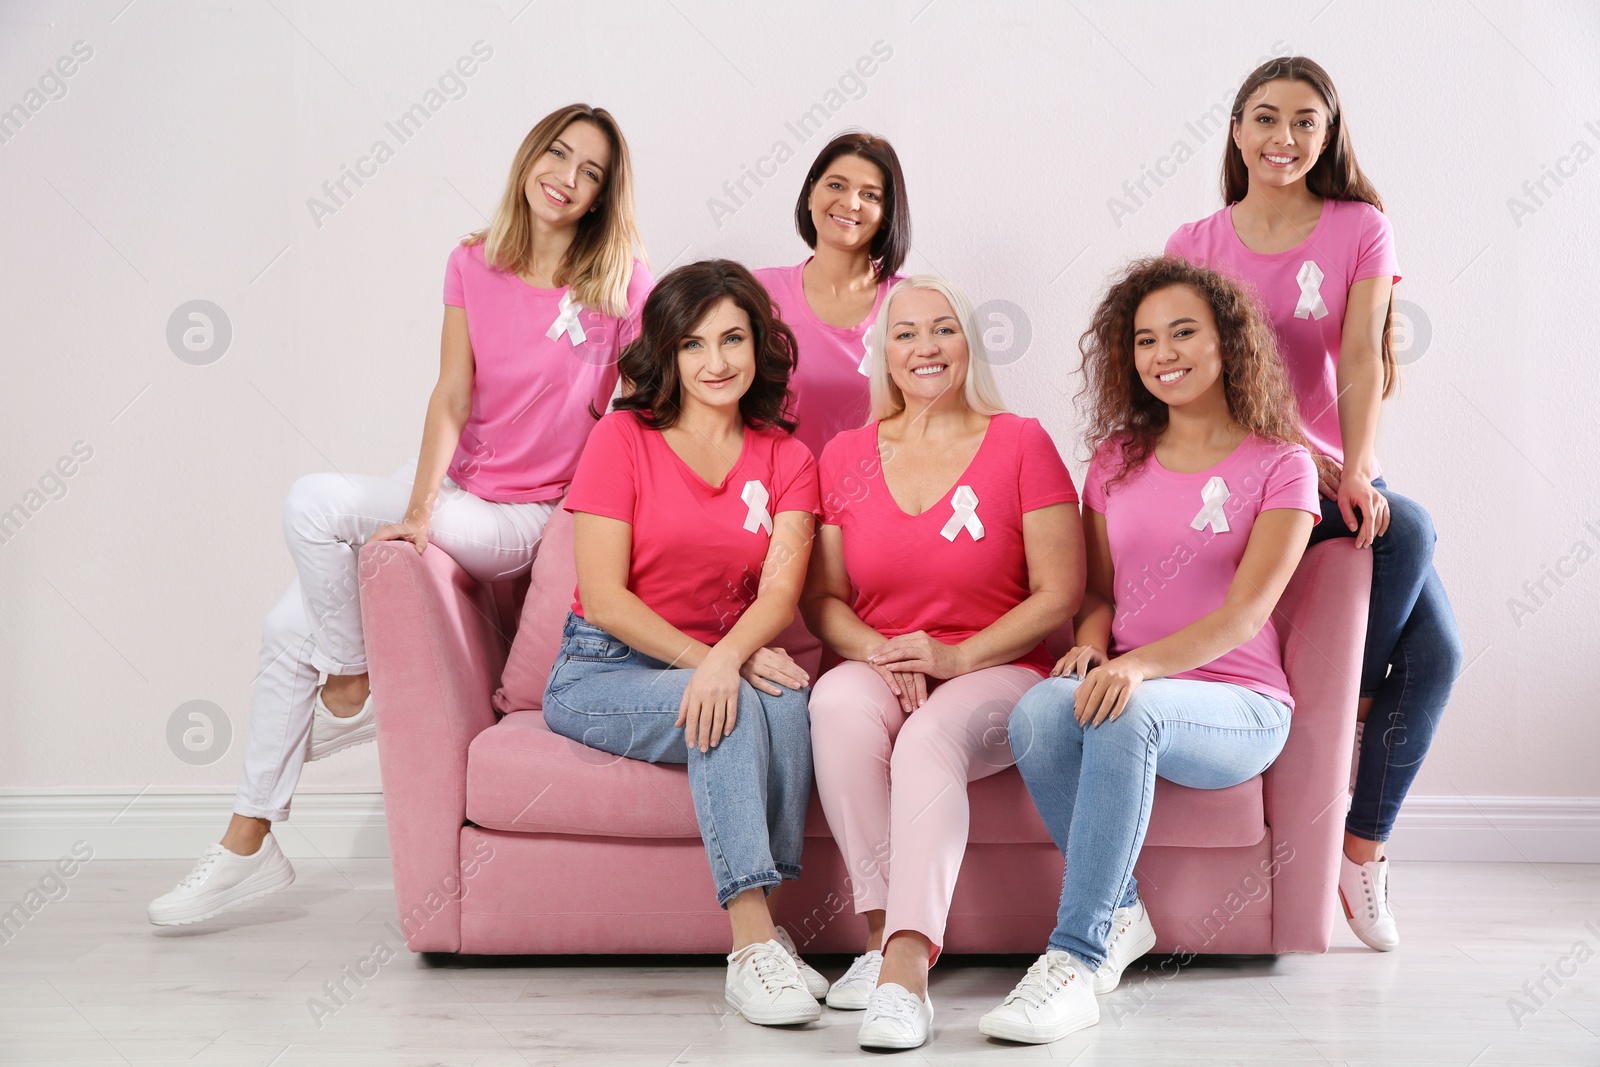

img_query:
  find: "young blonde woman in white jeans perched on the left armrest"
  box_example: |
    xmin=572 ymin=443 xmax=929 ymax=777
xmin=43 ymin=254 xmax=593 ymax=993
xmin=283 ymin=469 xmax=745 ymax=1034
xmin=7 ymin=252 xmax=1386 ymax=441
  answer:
xmin=149 ymin=104 xmax=651 ymax=926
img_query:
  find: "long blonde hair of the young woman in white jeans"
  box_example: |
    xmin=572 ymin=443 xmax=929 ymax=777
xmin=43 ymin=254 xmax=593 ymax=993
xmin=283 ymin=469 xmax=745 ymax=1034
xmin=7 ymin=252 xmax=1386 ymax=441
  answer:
xmin=462 ymin=104 xmax=645 ymax=317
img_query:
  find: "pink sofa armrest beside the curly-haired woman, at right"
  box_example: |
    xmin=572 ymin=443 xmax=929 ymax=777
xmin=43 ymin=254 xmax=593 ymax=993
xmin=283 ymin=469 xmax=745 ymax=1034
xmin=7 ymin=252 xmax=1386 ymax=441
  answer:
xmin=1262 ymin=537 xmax=1373 ymax=952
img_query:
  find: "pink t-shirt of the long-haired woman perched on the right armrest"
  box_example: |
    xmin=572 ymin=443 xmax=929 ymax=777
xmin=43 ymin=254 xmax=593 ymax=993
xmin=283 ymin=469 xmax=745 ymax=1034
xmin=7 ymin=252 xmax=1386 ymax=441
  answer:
xmin=1166 ymin=200 xmax=1400 ymax=464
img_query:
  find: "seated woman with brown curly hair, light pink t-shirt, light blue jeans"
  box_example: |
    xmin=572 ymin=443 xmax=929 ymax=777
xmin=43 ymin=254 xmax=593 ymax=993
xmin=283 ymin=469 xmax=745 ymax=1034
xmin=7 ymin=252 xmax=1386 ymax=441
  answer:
xmin=979 ymin=259 xmax=1320 ymax=1043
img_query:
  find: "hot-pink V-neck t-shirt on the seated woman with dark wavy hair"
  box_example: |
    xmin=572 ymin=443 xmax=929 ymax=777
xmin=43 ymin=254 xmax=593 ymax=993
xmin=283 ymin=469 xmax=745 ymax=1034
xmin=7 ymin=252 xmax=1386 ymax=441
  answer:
xmin=563 ymin=411 xmax=818 ymax=645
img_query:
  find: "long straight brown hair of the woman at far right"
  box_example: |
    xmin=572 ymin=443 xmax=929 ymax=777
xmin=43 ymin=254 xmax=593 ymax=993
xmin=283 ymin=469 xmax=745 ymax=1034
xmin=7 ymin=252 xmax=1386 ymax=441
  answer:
xmin=1222 ymin=56 xmax=1400 ymax=397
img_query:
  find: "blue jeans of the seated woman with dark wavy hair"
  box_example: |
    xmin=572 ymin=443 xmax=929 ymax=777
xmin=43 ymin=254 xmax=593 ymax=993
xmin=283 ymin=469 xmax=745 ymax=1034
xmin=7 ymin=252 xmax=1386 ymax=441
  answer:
xmin=544 ymin=613 xmax=811 ymax=907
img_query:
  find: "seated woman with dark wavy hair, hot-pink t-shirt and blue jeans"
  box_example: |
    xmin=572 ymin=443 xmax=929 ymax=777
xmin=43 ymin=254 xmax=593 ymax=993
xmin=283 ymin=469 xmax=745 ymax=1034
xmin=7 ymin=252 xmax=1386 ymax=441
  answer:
xmin=544 ymin=259 xmax=826 ymax=1025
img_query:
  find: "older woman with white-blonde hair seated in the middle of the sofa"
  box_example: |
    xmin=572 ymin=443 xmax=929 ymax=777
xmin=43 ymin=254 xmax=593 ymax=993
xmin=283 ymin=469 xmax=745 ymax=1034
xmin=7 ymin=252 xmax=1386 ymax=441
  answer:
xmin=802 ymin=275 xmax=1085 ymax=1048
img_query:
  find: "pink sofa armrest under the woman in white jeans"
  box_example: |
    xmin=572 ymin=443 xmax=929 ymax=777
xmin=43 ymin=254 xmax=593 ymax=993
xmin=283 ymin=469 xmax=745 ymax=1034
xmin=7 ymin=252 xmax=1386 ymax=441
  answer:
xmin=360 ymin=541 xmax=506 ymax=952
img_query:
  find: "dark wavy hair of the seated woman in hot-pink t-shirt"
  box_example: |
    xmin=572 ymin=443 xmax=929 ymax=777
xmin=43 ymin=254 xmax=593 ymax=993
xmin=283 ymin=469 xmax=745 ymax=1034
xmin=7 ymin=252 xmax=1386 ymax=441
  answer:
xmin=613 ymin=259 xmax=800 ymax=434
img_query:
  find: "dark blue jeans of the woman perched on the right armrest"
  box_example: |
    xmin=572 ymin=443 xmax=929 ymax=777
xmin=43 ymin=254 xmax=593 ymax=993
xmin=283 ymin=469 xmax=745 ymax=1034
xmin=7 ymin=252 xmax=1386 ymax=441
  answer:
xmin=1310 ymin=478 xmax=1461 ymax=841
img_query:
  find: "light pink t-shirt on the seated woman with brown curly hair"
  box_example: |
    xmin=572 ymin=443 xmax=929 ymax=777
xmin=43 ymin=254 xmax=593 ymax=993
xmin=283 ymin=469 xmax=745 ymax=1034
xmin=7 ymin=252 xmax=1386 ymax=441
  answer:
xmin=1083 ymin=435 xmax=1322 ymax=707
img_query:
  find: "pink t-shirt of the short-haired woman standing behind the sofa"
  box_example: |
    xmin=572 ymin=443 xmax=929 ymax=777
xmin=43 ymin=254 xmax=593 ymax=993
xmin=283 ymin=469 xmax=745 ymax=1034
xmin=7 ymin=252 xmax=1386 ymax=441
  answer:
xmin=755 ymin=259 xmax=901 ymax=456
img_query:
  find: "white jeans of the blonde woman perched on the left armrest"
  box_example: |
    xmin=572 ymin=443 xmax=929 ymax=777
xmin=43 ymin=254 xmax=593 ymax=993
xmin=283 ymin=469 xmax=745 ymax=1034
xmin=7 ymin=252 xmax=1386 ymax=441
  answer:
xmin=234 ymin=462 xmax=555 ymax=821
